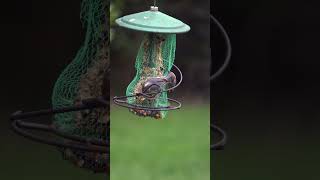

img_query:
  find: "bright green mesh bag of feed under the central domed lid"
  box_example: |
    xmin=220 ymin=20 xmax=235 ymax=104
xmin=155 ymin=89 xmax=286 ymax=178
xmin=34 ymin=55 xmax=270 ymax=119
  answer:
xmin=126 ymin=34 xmax=176 ymax=118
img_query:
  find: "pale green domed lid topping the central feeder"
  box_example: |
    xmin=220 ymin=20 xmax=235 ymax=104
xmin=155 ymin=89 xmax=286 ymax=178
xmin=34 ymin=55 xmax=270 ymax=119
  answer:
xmin=116 ymin=6 xmax=190 ymax=33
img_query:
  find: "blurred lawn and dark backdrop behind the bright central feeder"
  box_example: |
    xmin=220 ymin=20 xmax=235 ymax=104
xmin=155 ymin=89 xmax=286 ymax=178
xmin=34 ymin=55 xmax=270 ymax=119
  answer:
xmin=111 ymin=0 xmax=210 ymax=180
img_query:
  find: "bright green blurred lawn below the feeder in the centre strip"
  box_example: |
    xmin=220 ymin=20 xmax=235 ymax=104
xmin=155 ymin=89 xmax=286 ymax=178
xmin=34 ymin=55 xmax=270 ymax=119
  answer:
xmin=110 ymin=105 xmax=210 ymax=180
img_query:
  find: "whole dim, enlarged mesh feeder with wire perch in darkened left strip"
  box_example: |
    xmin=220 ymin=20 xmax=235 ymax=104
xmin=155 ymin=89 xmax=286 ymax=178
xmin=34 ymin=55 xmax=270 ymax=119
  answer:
xmin=11 ymin=0 xmax=110 ymax=173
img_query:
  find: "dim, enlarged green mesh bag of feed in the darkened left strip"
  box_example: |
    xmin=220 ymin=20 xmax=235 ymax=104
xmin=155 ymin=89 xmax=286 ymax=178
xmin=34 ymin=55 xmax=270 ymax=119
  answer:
xmin=52 ymin=0 xmax=109 ymax=172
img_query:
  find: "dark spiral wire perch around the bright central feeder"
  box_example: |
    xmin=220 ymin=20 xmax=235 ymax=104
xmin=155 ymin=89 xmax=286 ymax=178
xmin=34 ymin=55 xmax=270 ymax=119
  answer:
xmin=113 ymin=64 xmax=183 ymax=111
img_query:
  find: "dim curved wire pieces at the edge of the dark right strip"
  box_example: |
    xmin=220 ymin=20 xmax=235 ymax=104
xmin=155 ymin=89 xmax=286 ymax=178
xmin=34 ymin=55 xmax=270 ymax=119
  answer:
xmin=210 ymin=14 xmax=232 ymax=150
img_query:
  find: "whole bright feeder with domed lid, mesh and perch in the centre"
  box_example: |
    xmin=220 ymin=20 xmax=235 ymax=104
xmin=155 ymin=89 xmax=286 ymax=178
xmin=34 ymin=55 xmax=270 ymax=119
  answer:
xmin=113 ymin=3 xmax=190 ymax=119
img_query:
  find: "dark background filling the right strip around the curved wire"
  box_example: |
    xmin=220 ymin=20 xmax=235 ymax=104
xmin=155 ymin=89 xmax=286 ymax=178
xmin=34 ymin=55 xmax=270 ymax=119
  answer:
xmin=211 ymin=0 xmax=320 ymax=180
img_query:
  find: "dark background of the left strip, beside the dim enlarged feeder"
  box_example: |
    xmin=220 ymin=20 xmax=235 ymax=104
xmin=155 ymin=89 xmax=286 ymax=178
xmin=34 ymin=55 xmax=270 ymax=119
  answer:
xmin=0 ymin=0 xmax=106 ymax=180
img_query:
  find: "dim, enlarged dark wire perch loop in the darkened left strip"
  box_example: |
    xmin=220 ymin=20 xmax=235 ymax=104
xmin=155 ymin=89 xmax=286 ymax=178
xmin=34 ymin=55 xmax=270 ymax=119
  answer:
xmin=10 ymin=98 xmax=109 ymax=154
